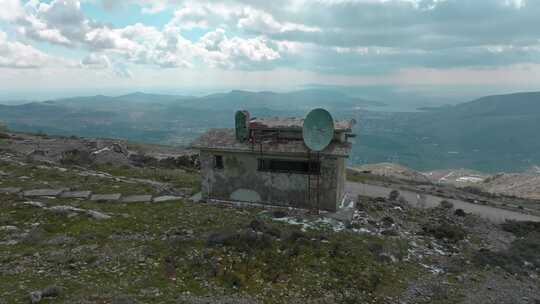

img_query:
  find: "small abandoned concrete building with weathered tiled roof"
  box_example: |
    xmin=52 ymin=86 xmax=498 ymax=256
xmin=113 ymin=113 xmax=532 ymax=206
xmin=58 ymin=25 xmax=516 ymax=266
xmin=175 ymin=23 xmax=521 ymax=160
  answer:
xmin=192 ymin=111 xmax=355 ymax=211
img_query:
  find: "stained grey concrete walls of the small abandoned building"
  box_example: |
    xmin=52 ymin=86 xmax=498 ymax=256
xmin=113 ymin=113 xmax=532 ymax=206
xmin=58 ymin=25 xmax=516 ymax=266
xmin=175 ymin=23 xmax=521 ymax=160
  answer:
xmin=200 ymin=151 xmax=345 ymax=211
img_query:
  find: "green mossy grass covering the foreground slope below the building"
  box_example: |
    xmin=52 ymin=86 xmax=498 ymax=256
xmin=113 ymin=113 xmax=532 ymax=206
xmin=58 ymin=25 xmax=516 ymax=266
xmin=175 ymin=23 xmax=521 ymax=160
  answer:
xmin=0 ymin=163 xmax=421 ymax=303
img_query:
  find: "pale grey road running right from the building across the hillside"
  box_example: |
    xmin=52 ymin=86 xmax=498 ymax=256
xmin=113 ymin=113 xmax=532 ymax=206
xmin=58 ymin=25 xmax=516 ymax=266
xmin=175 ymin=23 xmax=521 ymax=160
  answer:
xmin=345 ymin=182 xmax=540 ymax=223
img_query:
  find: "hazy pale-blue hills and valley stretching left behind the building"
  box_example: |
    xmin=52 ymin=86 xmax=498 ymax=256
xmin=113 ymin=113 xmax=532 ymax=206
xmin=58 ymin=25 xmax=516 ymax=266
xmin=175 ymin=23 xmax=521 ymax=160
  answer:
xmin=0 ymin=90 xmax=376 ymax=144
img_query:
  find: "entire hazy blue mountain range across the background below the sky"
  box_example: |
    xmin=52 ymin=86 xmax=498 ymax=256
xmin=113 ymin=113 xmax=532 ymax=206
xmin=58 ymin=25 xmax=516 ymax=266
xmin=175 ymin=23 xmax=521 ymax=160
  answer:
xmin=0 ymin=88 xmax=540 ymax=172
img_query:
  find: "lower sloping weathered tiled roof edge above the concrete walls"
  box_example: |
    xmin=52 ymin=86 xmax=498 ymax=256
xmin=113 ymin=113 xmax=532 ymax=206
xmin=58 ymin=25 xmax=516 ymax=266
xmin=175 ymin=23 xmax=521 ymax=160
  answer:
xmin=191 ymin=129 xmax=351 ymax=157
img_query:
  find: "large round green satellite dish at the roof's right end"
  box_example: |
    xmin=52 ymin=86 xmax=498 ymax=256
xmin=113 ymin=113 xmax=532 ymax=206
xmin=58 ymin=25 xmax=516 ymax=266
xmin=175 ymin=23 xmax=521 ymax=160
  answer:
xmin=302 ymin=109 xmax=334 ymax=152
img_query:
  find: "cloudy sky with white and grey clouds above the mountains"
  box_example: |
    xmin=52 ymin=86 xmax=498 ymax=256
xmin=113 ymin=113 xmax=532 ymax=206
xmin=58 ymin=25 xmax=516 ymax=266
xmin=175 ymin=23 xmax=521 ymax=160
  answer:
xmin=0 ymin=0 xmax=540 ymax=99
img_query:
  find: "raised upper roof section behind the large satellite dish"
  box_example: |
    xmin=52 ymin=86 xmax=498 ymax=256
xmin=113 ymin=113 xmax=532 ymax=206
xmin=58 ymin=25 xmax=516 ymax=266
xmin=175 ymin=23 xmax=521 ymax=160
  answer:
xmin=249 ymin=117 xmax=356 ymax=132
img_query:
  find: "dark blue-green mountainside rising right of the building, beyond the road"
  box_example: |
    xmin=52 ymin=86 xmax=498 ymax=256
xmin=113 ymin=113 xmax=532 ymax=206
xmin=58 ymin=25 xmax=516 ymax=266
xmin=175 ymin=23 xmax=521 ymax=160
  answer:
xmin=354 ymin=92 xmax=540 ymax=172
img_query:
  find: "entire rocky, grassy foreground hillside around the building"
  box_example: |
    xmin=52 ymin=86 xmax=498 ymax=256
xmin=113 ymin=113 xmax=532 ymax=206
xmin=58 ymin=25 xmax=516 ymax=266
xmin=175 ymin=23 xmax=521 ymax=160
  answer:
xmin=0 ymin=134 xmax=540 ymax=304
